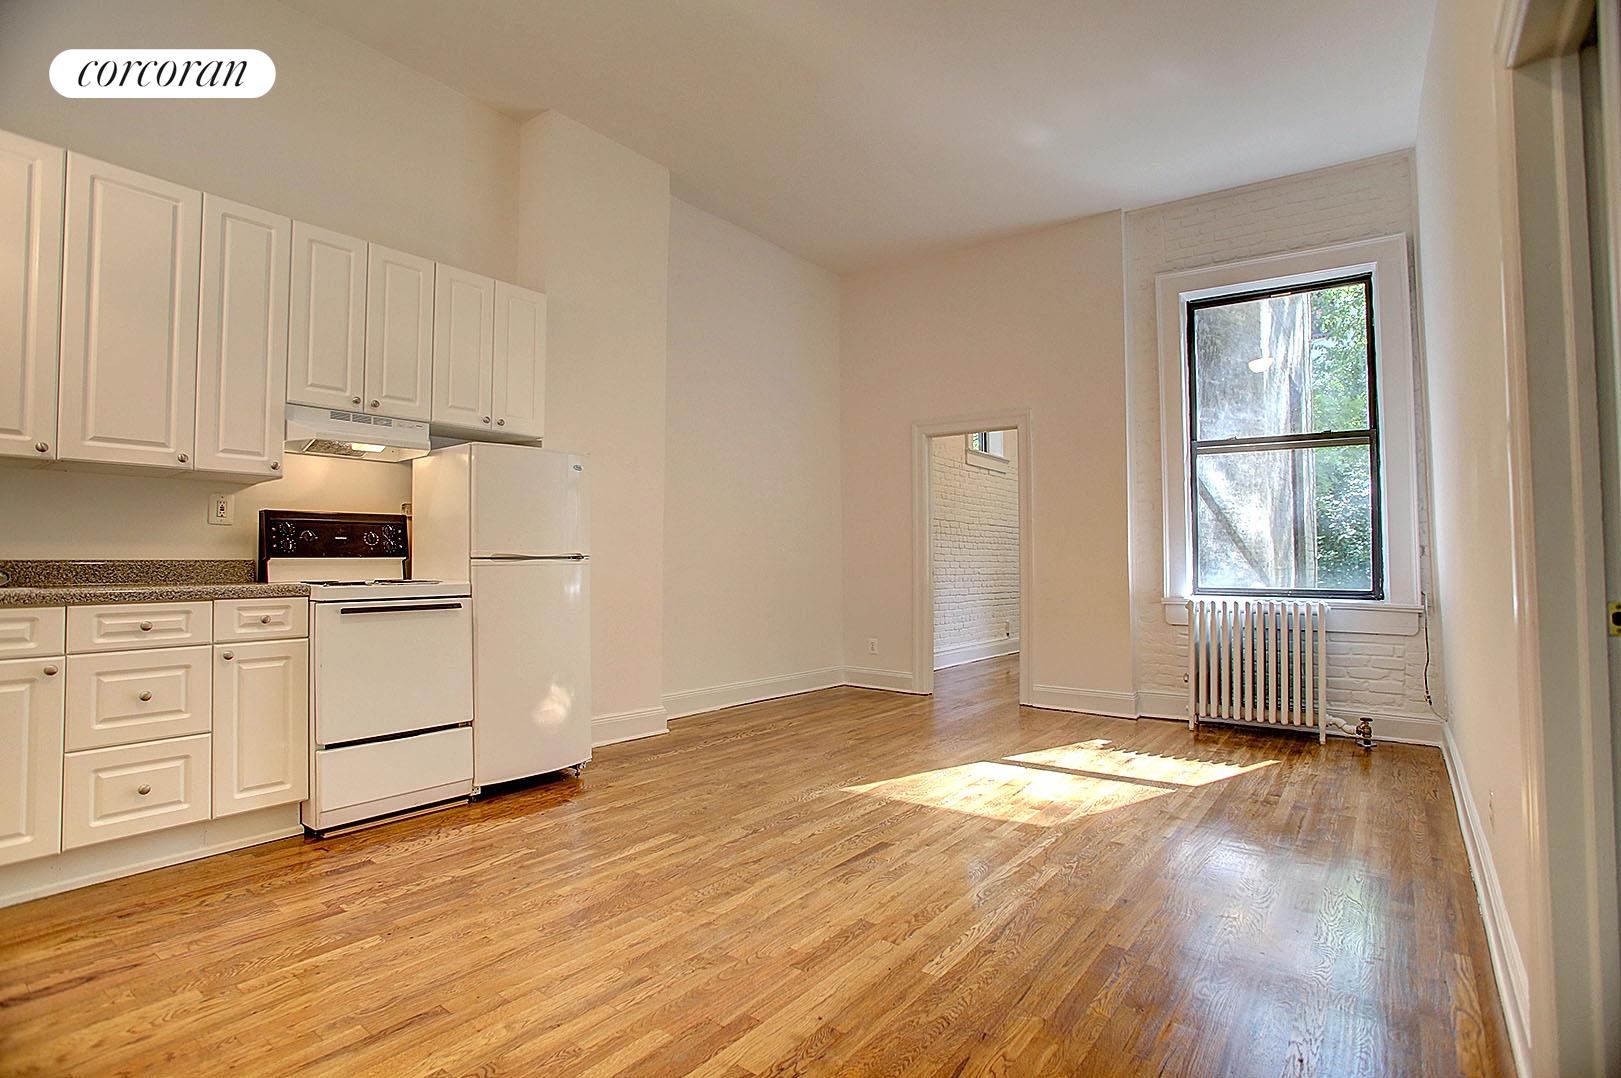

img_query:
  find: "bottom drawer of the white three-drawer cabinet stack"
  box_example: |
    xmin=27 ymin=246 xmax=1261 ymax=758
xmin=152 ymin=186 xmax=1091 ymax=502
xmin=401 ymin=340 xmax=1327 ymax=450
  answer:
xmin=62 ymin=734 xmax=209 ymax=849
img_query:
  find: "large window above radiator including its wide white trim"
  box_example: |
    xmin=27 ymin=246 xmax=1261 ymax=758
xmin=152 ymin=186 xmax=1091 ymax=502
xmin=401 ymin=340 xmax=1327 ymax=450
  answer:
xmin=1154 ymin=235 xmax=1423 ymax=625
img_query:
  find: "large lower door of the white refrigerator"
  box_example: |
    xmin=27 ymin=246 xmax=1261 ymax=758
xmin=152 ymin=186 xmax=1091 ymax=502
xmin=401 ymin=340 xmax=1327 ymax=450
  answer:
xmin=473 ymin=561 xmax=592 ymax=786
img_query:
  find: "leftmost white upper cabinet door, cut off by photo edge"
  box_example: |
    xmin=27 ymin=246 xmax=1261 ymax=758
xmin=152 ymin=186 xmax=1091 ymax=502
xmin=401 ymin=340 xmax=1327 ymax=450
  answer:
xmin=0 ymin=131 xmax=66 ymax=460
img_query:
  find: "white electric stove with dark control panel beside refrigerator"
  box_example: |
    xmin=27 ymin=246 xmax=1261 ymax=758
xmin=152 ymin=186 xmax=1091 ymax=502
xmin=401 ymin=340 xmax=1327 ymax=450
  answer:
xmin=259 ymin=509 xmax=473 ymax=832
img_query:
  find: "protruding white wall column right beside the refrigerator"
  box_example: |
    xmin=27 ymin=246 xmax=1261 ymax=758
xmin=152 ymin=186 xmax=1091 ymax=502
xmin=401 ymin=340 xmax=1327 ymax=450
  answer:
xmin=519 ymin=112 xmax=669 ymax=728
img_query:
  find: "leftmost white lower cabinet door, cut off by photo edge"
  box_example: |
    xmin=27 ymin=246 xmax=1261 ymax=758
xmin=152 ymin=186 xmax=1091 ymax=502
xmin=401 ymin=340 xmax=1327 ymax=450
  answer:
xmin=0 ymin=658 xmax=65 ymax=864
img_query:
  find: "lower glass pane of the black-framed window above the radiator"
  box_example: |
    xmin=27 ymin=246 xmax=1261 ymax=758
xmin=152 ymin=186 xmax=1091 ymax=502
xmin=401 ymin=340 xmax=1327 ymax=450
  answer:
xmin=1195 ymin=446 xmax=1373 ymax=592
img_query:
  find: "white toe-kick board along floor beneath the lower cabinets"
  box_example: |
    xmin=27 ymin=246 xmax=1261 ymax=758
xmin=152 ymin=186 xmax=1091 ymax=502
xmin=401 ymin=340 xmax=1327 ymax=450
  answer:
xmin=0 ymin=804 xmax=303 ymax=908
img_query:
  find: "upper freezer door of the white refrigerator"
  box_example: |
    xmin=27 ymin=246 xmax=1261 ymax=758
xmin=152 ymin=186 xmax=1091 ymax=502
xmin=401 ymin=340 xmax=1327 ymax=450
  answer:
xmin=472 ymin=443 xmax=590 ymax=558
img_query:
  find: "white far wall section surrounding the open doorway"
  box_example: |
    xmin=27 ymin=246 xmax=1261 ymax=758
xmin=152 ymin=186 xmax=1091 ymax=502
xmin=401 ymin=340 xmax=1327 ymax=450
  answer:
xmin=840 ymin=214 xmax=1133 ymax=712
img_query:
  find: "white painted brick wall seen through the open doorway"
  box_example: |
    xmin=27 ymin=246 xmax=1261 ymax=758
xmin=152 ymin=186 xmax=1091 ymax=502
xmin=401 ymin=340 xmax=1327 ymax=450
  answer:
xmin=929 ymin=438 xmax=1020 ymax=652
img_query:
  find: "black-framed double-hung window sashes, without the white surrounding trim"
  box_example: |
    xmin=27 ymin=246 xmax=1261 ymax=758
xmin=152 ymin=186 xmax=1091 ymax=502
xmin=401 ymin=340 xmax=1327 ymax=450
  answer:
xmin=1185 ymin=272 xmax=1384 ymax=600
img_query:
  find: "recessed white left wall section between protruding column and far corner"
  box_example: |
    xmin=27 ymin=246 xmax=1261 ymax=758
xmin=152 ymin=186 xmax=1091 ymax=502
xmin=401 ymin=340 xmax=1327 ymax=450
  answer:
xmin=663 ymin=201 xmax=843 ymax=715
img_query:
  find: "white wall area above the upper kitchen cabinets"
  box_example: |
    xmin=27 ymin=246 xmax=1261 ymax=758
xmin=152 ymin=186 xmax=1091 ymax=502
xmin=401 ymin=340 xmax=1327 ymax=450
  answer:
xmin=0 ymin=0 xmax=519 ymax=279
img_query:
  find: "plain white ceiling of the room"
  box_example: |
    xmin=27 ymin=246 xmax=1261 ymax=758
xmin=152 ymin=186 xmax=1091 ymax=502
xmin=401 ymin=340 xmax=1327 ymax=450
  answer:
xmin=292 ymin=0 xmax=1433 ymax=269
